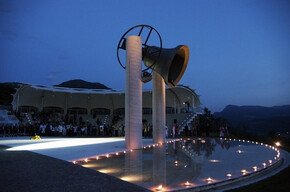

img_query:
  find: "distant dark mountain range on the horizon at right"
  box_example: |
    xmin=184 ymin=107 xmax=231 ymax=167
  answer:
xmin=214 ymin=105 xmax=290 ymax=135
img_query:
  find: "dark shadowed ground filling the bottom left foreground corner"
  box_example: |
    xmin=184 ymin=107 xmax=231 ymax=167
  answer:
xmin=0 ymin=146 xmax=148 ymax=192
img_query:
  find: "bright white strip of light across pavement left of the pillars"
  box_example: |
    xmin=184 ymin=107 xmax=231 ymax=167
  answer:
xmin=7 ymin=138 xmax=124 ymax=151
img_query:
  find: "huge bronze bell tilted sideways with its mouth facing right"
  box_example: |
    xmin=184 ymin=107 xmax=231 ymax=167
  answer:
xmin=142 ymin=45 xmax=189 ymax=88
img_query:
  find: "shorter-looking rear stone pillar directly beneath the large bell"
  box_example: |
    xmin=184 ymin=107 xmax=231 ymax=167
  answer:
xmin=152 ymin=71 xmax=166 ymax=143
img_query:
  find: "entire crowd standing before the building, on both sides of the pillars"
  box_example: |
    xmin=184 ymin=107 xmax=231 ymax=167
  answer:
xmin=0 ymin=113 xmax=229 ymax=138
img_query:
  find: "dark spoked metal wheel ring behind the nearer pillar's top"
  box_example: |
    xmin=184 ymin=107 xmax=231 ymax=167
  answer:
xmin=117 ymin=25 xmax=162 ymax=72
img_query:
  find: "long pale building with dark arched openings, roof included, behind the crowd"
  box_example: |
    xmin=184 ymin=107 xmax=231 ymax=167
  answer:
xmin=12 ymin=84 xmax=201 ymax=129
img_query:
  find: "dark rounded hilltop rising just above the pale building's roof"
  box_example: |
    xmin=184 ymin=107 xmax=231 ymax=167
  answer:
xmin=54 ymin=79 xmax=111 ymax=89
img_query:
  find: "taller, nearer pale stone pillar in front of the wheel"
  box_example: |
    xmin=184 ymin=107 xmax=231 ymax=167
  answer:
xmin=125 ymin=35 xmax=142 ymax=149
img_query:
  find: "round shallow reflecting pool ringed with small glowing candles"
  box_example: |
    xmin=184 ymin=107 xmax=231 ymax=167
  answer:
xmin=77 ymin=138 xmax=279 ymax=191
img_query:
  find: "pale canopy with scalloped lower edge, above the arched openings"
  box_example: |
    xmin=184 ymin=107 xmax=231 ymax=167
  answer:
xmin=12 ymin=85 xmax=201 ymax=115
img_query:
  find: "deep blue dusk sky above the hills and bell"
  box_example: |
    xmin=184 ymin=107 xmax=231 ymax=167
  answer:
xmin=0 ymin=0 xmax=290 ymax=112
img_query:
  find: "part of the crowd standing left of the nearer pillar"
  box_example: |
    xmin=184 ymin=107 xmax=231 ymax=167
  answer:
xmin=0 ymin=113 xmax=125 ymax=137
